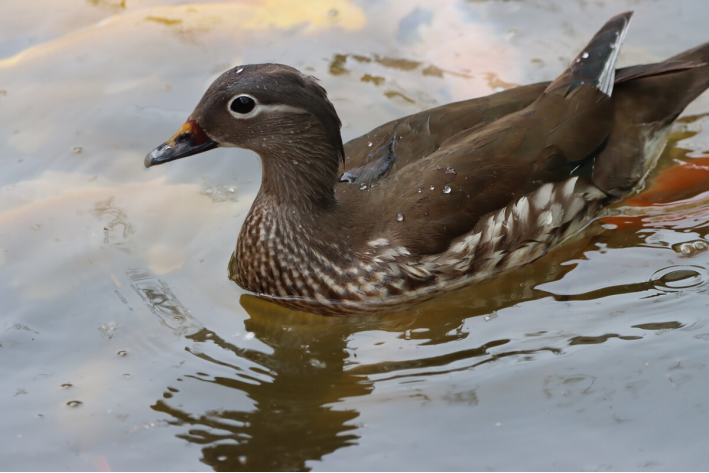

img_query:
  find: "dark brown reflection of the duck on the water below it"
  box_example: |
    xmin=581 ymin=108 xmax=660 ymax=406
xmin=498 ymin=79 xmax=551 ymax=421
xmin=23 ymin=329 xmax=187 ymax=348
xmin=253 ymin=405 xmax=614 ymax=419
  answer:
xmin=152 ymin=234 xmax=590 ymax=471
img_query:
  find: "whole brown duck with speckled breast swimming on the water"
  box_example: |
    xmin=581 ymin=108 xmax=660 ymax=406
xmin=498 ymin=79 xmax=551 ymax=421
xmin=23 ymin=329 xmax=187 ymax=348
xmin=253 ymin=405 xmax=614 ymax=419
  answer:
xmin=144 ymin=12 xmax=709 ymax=316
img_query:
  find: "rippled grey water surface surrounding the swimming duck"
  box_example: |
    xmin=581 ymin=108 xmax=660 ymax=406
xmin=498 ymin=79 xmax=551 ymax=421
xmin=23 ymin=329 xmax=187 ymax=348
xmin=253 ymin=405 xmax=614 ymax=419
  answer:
xmin=0 ymin=0 xmax=709 ymax=471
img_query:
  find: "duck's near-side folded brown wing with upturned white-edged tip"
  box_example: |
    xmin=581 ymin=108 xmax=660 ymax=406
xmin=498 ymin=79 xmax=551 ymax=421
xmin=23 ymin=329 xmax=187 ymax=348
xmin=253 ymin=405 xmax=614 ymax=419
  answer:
xmin=348 ymin=13 xmax=631 ymax=255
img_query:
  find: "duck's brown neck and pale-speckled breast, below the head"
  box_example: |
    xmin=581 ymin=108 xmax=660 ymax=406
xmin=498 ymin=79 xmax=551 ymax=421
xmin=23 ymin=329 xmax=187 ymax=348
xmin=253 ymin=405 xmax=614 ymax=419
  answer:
xmin=230 ymin=125 xmax=349 ymax=296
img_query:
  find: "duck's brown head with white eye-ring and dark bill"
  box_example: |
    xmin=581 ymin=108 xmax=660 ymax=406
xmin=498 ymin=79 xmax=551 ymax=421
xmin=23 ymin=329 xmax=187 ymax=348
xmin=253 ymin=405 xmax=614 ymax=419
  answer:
xmin=145 ymin=64 xmax=344 ymax=167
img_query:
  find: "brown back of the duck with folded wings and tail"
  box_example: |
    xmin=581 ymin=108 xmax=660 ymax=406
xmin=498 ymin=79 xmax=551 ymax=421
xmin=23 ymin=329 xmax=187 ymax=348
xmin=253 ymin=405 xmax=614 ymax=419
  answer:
xmin=337 ymin=14 xmax=709 ymax=262
